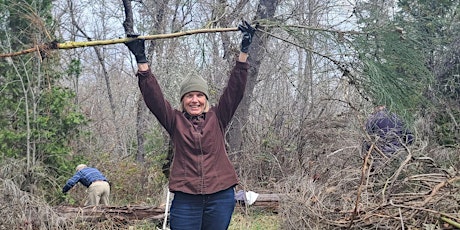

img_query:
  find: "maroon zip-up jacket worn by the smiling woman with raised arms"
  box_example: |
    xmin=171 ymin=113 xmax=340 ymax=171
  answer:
xmin=137 ymin=62 xmax=249 ymax=194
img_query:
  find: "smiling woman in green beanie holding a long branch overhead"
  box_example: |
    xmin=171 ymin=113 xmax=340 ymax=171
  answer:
xmin=125 ymin=21 xmax=255 ymax=230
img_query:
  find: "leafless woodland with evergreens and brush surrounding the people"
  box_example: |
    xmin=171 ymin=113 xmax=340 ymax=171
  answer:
xmin=0 ymin=0 xmax=460 ymax=229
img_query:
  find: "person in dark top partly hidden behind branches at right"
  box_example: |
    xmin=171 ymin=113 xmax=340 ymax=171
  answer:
xmin=366 ymin=105 xmax=414 ymax=157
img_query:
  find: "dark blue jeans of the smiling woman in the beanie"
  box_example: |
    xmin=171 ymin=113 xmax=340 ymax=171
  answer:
xmin=170 ymin=187 xmax=235 ymax=230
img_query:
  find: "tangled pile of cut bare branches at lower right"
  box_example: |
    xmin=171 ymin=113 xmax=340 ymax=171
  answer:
xmin=276 ymin=145 xmax=460 ymax=229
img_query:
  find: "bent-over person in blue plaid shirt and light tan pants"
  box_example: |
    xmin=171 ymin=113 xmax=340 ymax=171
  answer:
xmin=62 ymin=164 xmax=110 ymax=206
